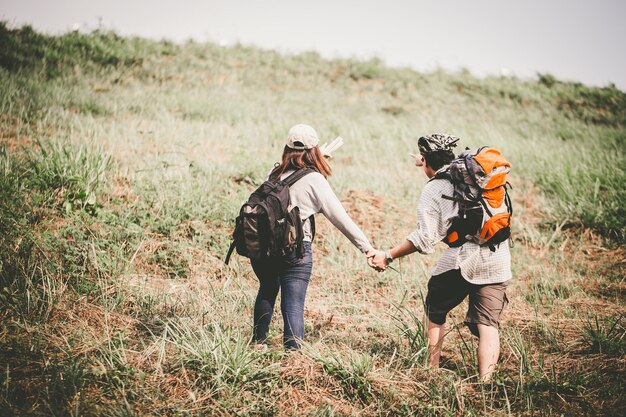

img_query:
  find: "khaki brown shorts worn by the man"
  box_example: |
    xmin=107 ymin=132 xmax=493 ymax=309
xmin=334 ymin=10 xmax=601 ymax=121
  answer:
xmin=426 ymin=269 xmax=509 ymax=336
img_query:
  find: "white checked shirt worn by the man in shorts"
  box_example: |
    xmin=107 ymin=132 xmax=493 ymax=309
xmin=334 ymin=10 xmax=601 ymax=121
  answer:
xmin=407 ymin=169 xmax=512 ymax=284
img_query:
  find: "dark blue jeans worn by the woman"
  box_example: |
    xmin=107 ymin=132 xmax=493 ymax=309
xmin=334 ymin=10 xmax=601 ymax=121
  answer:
xmin=252 ymin=242 xmax=313 ymax=350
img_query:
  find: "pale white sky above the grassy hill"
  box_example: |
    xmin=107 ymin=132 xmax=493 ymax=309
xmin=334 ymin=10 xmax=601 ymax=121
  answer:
xmin=0 ymin=0 xmax=626 ymax=90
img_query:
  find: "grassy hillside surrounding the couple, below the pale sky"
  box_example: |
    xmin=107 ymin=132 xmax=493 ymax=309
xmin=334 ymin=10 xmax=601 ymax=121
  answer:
xmin=0 ymin=24 xmax=626 ymax=416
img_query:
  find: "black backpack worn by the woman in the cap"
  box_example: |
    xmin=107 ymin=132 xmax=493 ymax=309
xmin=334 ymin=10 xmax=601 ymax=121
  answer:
xmin=225 ymin=168 xmax=317 ymax=265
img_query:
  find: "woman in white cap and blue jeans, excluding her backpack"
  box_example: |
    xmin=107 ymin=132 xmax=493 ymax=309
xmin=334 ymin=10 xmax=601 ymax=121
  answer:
xmin=252 ymin=124 xmax=376 ymax=350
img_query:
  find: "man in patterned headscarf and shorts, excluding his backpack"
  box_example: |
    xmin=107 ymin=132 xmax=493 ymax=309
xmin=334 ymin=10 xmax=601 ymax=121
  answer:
xmin=369 ymin=134 xmax=511 ymax=382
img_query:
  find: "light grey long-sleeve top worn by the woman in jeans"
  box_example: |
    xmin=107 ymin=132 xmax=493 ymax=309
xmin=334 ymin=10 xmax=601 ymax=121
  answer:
xmin=280 ymin=171 xmax=372 ymax=253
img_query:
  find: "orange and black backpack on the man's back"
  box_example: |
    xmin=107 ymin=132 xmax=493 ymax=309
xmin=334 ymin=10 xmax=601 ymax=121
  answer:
xmin=433 ymin=146 xmax=513 ymax=251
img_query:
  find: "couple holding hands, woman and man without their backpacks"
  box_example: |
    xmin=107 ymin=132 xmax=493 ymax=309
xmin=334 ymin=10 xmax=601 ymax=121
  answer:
xmin=241 ymin=124 xmax=511 ymax=381
